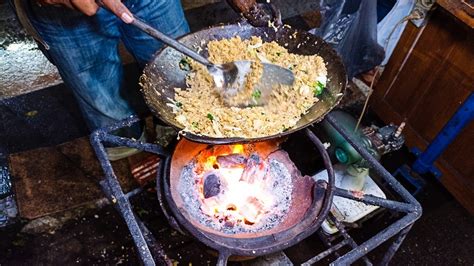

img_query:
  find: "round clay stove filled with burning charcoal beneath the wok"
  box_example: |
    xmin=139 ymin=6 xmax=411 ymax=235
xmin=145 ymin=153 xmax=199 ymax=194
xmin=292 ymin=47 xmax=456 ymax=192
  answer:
xmin=163 ymin=134 xmax=332 ymax=264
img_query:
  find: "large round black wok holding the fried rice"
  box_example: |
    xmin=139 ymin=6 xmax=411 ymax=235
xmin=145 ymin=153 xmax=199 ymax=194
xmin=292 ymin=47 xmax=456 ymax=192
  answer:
xmin=141 ymin=23 xmax=347 ymax=144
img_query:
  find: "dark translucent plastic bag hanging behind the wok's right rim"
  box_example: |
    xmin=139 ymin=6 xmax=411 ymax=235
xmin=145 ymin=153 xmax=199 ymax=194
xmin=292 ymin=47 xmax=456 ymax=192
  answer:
xmin=310 ymin=0 xmax=384 ymax=79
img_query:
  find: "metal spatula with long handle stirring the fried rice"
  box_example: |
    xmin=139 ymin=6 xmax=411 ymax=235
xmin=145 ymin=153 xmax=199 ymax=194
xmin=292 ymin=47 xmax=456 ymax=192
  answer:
xmin=105 ymin=10 xmax=295 ymax=107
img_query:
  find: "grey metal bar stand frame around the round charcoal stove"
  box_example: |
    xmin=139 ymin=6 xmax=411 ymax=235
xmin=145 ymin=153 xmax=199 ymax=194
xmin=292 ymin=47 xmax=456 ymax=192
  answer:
xmin=91 ymin=114 xmax=422 ymax=265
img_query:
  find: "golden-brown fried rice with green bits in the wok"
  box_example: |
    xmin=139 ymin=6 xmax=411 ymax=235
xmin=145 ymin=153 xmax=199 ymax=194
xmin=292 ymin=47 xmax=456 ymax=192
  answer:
xmin=168 ymin=37 xmax=327 ymax=138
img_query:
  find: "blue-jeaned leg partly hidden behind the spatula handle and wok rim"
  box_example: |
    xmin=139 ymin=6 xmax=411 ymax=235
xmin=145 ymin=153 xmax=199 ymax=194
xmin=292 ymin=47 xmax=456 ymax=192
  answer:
xmin=120 ymin=0 xmax=189 ymax=67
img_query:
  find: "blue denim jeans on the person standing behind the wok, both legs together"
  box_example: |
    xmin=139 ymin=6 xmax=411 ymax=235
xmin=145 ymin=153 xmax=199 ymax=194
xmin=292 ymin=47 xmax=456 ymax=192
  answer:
xmin=25 ymin=0 xmax=189 ymax=130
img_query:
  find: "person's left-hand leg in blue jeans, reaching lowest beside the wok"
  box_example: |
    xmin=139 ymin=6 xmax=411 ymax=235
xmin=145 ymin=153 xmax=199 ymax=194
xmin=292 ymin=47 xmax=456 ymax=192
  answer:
xmin=25 ymin=1 xmax=134 ymax=130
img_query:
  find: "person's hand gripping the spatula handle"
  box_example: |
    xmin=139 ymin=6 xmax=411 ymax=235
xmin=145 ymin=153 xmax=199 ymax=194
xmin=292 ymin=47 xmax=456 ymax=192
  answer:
xmin=38 ymin=0 xmax=134 ymax=23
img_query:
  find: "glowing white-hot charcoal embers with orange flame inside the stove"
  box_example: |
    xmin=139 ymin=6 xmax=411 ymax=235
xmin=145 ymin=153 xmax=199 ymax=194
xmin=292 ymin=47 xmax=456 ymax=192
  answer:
xmin=197 ymin=144 xmax=274 ymax=226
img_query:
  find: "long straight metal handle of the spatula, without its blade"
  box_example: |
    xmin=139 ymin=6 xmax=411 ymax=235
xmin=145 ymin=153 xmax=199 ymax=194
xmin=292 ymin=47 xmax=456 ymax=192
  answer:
xmin=95 ymin=0 xmax=214 ymax=67
